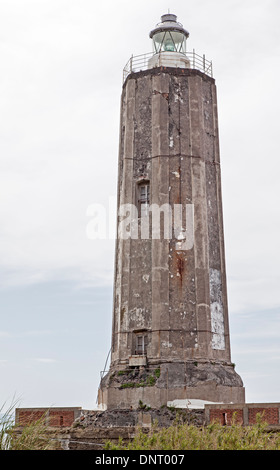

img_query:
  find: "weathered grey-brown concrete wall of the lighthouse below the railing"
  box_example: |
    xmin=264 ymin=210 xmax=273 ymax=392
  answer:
xmin=103 ymin=68 xmax=245 ymax=407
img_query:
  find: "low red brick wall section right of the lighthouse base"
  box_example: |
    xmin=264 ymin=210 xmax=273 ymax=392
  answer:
xmin=205 ymin=403 xmax=280 ymax=426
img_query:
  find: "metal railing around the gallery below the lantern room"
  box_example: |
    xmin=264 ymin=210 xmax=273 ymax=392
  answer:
xmin=123 ymin=50 xmax=213 ymax=81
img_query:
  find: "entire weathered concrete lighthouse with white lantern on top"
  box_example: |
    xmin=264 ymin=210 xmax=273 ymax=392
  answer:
xmin=99 ymin=14 xmax=245 ymax=409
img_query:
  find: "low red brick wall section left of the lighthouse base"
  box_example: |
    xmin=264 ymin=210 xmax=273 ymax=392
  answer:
xmin=15 ymin=407 xmax=82 ymax=427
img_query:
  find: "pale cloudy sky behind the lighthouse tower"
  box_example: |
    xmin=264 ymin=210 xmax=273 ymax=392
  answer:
xmin=0 ymin=0 xmax=280 ymax=409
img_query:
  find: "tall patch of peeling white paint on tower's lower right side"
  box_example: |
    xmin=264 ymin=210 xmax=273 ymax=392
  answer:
xmin=210 ymin=269 xmax=225 ymax=350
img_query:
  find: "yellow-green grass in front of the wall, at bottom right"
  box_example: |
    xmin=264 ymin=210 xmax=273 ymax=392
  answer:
xmin=105 ymin=416 xmax=280 ymax=450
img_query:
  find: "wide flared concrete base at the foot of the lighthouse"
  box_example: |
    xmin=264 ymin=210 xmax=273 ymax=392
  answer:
xmin=98 ymin=362 xmax=245 ymax=409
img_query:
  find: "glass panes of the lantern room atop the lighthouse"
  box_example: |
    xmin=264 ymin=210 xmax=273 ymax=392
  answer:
xmin=153 ymin=31 xmax=186 ymax=54
